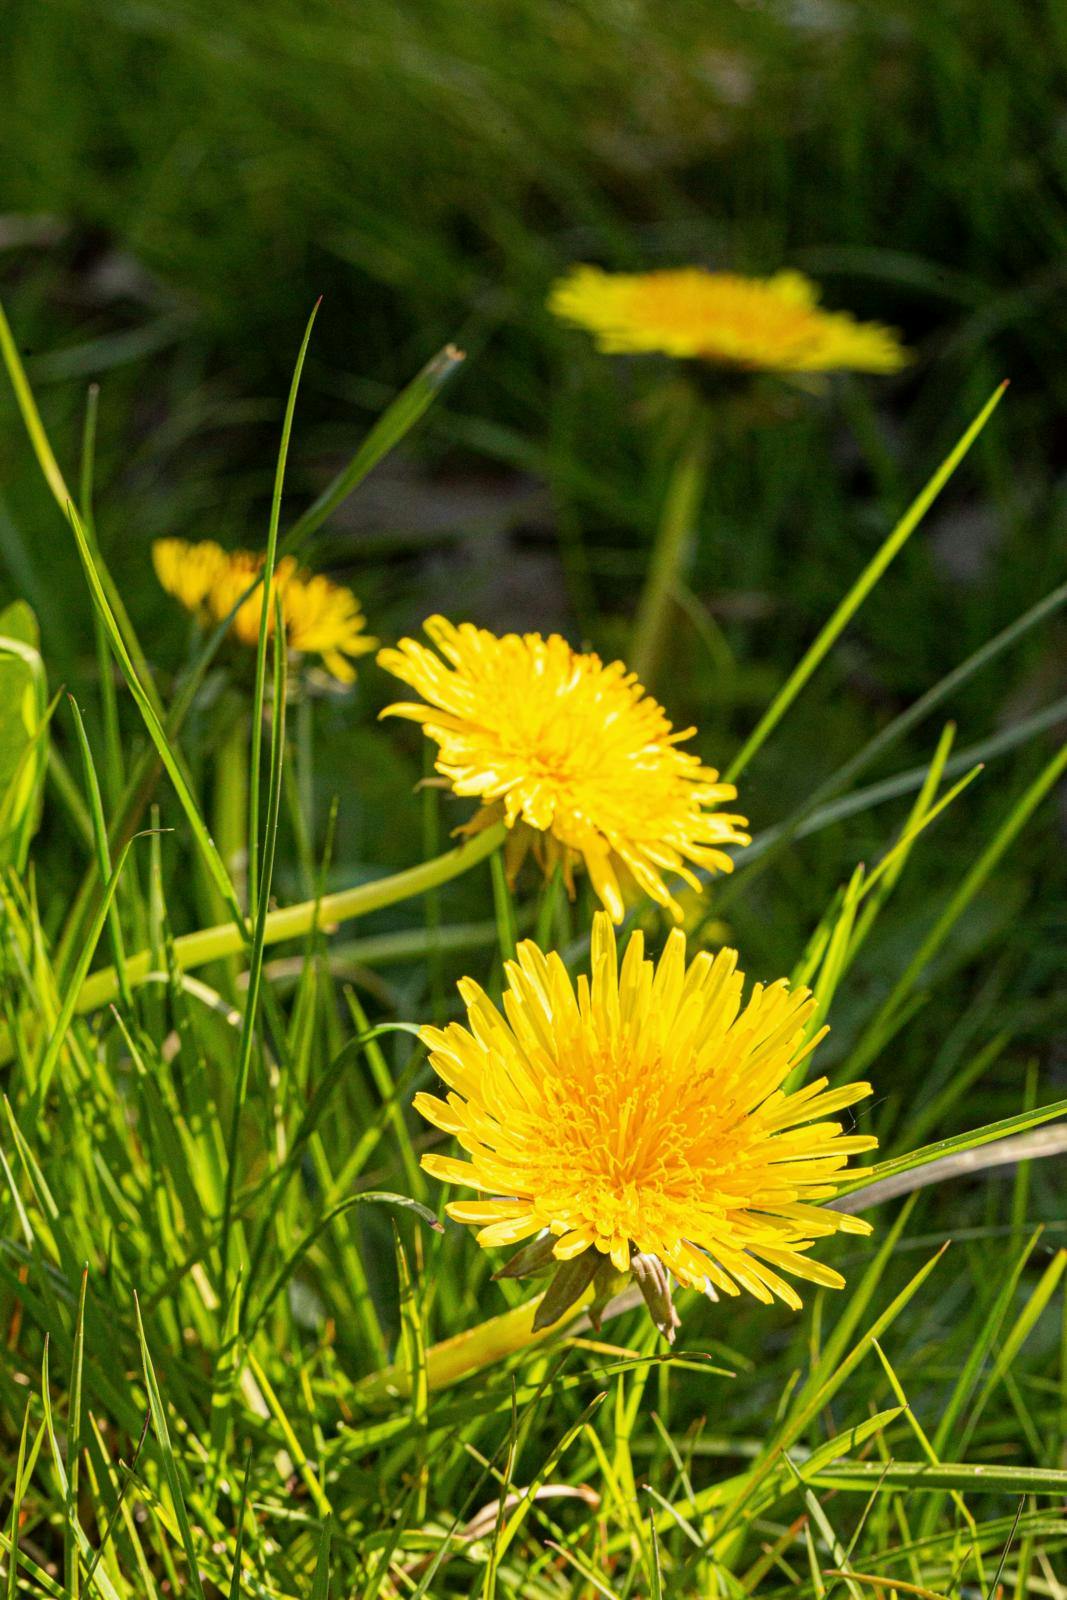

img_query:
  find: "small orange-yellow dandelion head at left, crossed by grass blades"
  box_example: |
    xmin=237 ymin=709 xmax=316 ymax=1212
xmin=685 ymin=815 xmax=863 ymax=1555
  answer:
xmin=152 ymin=539 xmax=378 ymax=683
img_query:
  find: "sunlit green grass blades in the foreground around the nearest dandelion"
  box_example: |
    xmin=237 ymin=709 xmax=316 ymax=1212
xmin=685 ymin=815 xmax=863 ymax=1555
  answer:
xmin=0 ymin=300 xmax=1067 ymax=1600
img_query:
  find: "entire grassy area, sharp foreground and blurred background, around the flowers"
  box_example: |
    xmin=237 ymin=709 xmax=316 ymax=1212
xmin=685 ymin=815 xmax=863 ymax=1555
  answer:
xmin=0 ymin=0 xmax=1067 ymax=1600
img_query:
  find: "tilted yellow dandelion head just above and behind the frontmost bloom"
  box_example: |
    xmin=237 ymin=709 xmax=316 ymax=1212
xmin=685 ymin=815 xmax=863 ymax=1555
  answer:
xmin=378 ymin=616 xmax=749 ymax=922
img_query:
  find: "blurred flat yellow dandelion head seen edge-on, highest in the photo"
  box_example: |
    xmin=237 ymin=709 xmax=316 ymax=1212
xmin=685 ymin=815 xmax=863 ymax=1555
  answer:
xmin=549 ymin=266 xmax=909 ymax=373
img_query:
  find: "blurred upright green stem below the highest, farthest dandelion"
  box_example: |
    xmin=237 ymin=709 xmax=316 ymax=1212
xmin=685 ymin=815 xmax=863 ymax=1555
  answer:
xmin=629 ymin=418 xmax=710 ymax=688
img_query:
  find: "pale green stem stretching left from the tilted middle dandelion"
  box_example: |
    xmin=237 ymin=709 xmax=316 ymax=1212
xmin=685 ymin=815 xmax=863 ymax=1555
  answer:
xmin=66 ymin=822 xmax=506 ymax=1017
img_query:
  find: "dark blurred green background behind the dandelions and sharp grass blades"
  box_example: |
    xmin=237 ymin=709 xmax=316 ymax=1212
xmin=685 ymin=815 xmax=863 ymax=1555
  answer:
xmin=0 ymin=0 xmax=1067 ymax=1100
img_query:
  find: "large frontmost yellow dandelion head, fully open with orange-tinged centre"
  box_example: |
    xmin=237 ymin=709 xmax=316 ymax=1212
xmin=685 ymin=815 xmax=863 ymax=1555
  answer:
xmin=414 ymin=912 xmax=877 ymax=1331
